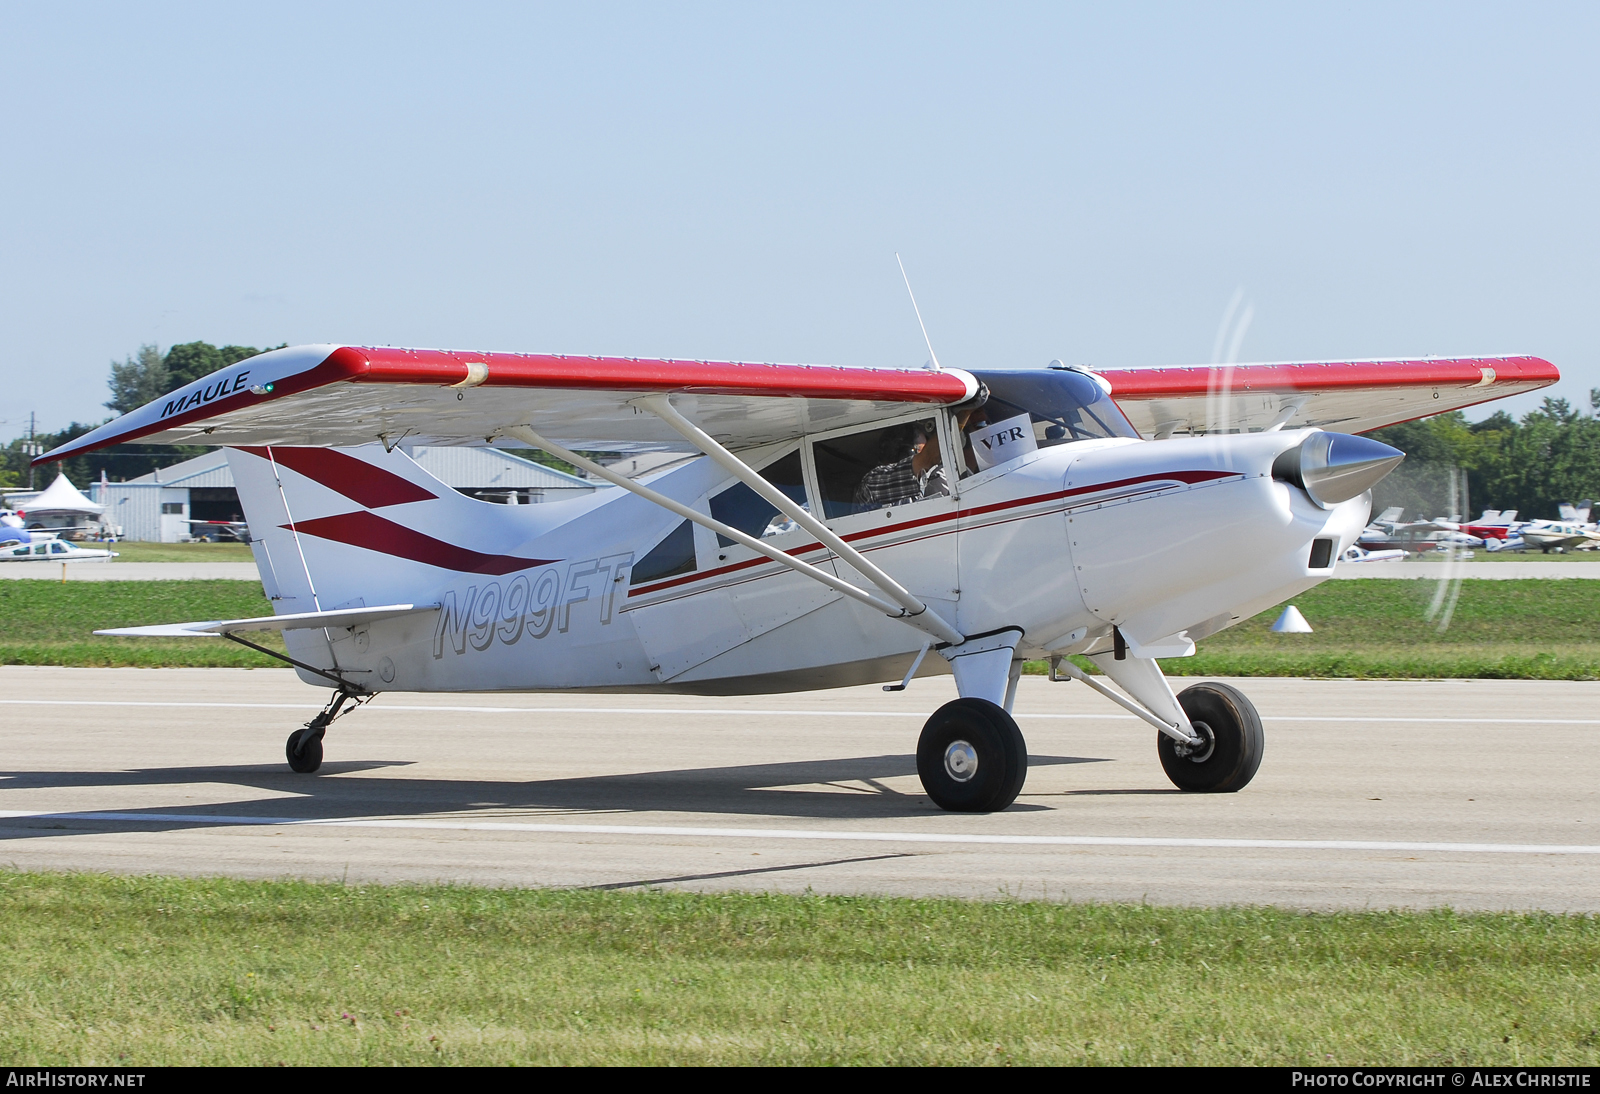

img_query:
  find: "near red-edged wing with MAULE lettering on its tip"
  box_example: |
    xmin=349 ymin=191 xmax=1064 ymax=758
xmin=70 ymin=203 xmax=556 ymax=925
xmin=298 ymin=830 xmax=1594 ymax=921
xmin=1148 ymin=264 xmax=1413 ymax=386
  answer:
xmin=38 ymin=345 xmax=978 ymax=462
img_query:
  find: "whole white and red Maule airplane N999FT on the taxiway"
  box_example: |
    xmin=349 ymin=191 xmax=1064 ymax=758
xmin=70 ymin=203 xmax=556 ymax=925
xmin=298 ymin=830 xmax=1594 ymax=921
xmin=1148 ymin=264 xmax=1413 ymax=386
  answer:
xmin=40 ymin=345 xmax=1558 ymax=811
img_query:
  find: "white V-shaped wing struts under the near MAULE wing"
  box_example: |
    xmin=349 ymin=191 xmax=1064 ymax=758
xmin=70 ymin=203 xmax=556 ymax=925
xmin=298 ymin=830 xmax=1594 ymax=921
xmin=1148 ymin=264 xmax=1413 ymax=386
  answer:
xmin=501 ymin=422 xmax=965 ymax=645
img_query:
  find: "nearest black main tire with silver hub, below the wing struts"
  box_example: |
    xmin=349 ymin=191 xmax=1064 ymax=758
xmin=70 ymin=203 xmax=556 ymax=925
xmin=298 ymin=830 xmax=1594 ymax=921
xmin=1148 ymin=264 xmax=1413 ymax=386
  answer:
xmin=917 ymin=699 xmax=1027 ymax=813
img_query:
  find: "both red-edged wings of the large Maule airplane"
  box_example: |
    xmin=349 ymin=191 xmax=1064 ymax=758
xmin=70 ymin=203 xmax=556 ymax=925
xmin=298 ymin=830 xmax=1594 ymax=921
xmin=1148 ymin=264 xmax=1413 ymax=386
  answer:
xmin=35 ymin=345 xmax=1560 ymax=462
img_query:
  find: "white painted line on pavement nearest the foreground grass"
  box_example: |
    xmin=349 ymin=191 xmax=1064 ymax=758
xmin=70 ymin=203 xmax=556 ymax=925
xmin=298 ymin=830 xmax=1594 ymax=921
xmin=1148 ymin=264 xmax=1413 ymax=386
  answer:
xmin=0 ymin=809 xmax=1600 ymax=854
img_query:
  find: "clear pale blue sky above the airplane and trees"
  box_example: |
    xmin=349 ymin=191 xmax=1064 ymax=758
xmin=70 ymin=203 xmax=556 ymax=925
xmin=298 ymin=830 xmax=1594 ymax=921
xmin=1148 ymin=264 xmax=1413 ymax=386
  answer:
xmin=0 ymin=3 xmax=1600 ymax=437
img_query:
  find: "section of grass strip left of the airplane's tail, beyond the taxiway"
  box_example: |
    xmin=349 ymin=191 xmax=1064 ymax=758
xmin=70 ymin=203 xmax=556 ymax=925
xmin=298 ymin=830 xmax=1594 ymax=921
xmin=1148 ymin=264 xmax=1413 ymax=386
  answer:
xmin=0 ymin=582 xmax=283 ymax=669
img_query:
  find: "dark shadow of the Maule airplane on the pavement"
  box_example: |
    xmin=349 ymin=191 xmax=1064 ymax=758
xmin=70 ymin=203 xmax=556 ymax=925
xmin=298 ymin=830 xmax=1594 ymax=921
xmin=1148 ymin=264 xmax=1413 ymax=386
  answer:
xmin=0 ymin=755 xmax=1104 ymax=840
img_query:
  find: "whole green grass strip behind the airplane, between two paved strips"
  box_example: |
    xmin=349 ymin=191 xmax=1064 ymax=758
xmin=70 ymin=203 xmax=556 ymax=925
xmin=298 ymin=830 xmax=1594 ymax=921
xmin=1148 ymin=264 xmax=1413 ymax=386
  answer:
xmin=0 ymin=579 xmax=1600 ymax=680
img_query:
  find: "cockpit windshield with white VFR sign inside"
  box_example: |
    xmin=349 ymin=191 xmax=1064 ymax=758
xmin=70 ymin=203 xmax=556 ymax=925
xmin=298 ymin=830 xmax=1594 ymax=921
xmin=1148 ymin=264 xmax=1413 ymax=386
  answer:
xmin=962 ymin=368 xmax=1139 ymax=470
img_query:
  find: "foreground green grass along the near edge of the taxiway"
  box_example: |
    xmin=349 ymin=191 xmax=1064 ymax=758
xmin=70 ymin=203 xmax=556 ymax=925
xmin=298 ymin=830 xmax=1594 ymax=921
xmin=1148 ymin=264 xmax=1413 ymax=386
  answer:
xmin=0 ymin=873 xmax=1600 ymax=1067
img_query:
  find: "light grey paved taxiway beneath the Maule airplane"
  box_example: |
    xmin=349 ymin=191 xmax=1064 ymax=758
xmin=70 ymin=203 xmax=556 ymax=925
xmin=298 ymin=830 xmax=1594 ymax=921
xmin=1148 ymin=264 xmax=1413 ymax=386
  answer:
xmin=0 ymin=667 xmax=1600 ymax=912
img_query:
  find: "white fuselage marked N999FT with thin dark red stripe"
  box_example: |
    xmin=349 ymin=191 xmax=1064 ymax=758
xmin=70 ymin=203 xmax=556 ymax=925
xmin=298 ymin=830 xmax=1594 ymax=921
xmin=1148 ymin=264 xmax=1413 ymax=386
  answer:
xmin=243 ymin=432 xmax=1370 ymax=694
